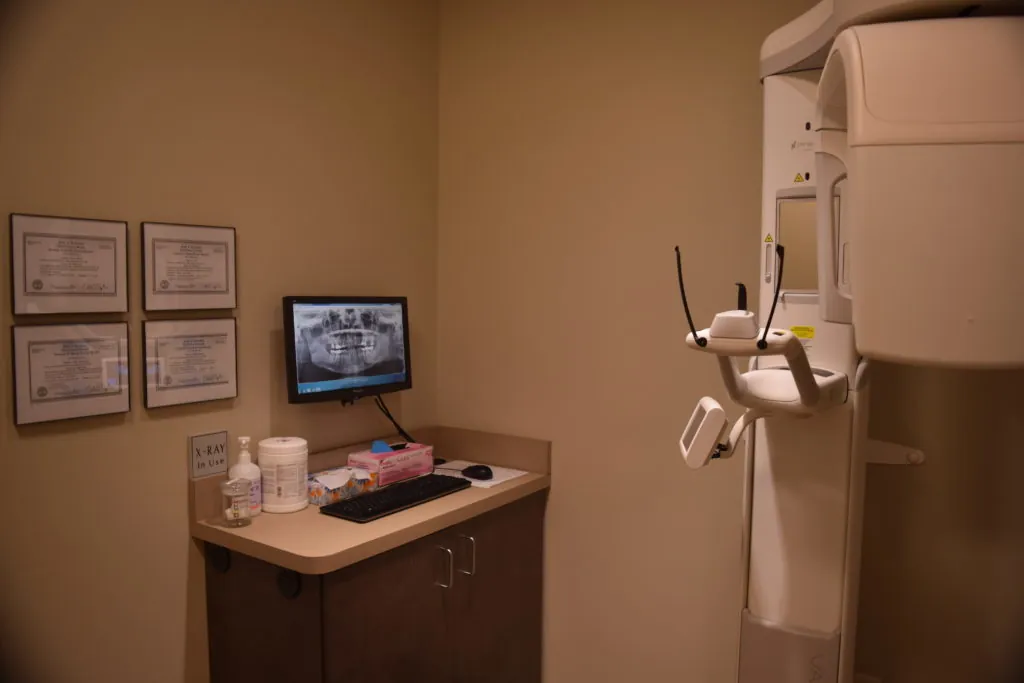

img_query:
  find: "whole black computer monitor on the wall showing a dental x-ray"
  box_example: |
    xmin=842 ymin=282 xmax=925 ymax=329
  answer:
xmin=282 ymin=296 xmax=413 ymax=403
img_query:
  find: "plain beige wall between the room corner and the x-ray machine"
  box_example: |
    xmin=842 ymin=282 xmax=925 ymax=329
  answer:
xmin=438 ymin=0 xmax=810 ymax=683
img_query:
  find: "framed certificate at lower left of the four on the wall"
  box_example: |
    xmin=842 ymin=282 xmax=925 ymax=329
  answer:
xmin=11 ymin=323 xmax=131 ymax=425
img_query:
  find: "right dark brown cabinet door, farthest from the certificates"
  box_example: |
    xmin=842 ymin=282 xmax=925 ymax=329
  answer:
xmin=450 ymin=492 xmax=547 ymax=683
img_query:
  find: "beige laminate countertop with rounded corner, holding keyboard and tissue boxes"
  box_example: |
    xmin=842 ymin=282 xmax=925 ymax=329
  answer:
xmin=191 ymin=473 xmax=551 ymax=574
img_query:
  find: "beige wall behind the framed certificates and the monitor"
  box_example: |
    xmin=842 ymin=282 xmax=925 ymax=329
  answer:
xmin=0 ymin=0 xmax=437 ymax=683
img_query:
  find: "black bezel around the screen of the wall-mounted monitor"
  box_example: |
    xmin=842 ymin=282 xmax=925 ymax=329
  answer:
xmin=281 ymin=296 xmax=413 ymax=403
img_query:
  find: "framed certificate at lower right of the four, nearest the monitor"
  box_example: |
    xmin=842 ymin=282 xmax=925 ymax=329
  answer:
xmin=143 ymin=317 xmax=239 ymax=408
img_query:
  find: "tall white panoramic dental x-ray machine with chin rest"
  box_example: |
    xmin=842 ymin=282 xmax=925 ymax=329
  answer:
xmin=677 ymin=0 xmax=1024 ymax=683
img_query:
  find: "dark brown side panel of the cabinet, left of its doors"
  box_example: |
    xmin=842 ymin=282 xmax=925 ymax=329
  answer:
xmin=205 ymin=545 xmax=321 ymax=683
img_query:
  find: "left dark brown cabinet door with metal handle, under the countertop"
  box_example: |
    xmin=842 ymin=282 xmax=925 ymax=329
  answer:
xmin=324 ymin=535 xmax=454 ymax=683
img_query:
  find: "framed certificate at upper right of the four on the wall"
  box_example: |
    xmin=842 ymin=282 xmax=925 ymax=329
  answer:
xmin=142 ymin=223 xmax=237 ymax=310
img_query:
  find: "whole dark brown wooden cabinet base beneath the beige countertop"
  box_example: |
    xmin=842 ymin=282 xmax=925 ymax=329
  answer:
xmin=207 ymin=492 xmax=546 ymax=683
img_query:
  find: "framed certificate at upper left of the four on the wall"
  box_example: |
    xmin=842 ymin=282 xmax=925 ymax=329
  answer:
xmin=10 ymin=213 xmax=128 ymax=315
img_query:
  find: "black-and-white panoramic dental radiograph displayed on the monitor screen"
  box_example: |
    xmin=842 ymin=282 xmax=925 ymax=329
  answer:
xmin=295 ymin=306 xmax=406 ymax=382
